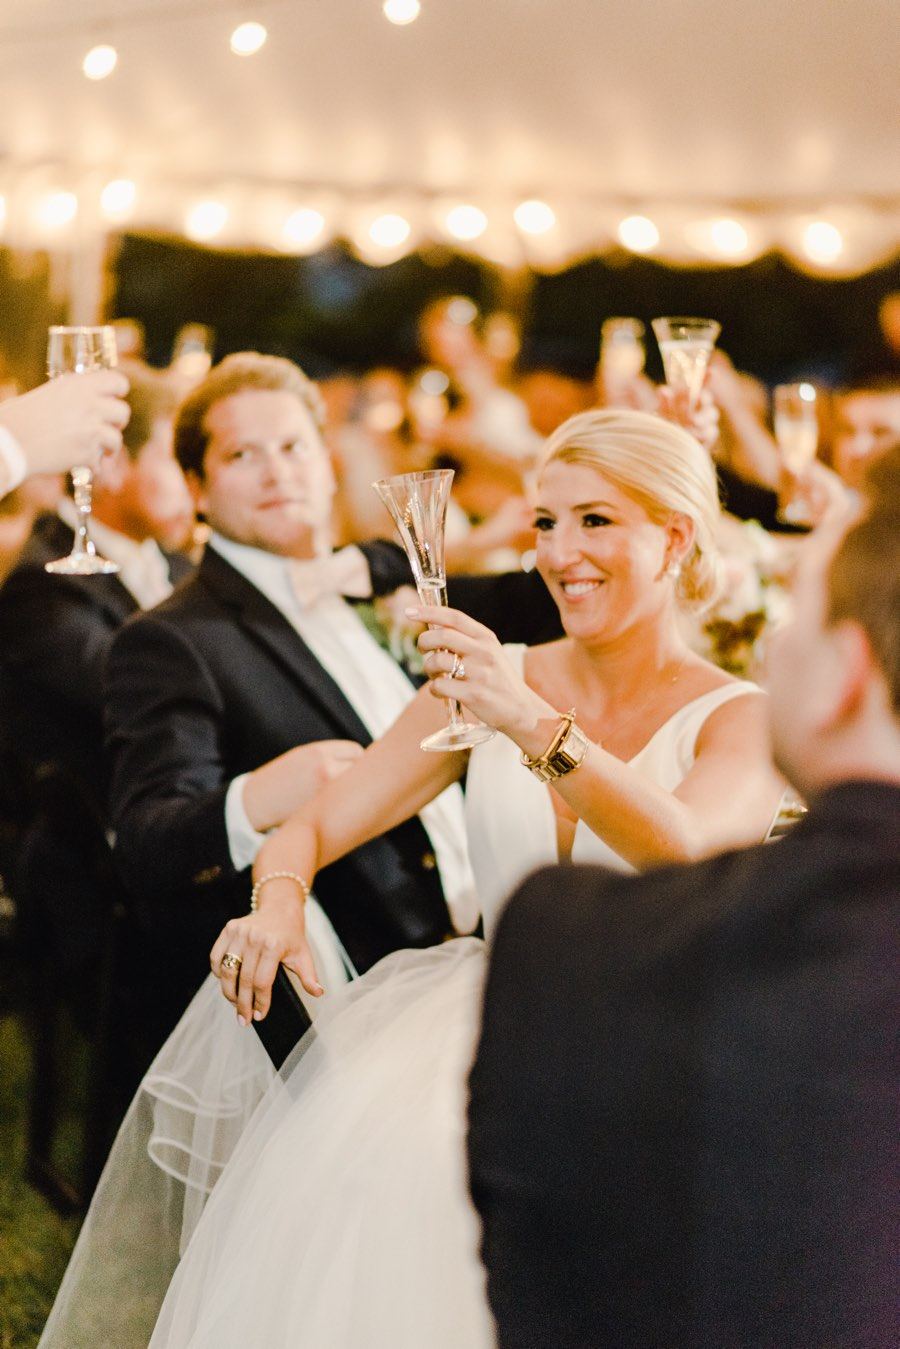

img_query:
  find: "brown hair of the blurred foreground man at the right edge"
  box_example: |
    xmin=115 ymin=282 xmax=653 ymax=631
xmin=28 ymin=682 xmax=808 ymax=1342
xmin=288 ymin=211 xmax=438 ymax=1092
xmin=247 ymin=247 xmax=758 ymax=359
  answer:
xmin=828 ymin=441 xmax=900 ymax=714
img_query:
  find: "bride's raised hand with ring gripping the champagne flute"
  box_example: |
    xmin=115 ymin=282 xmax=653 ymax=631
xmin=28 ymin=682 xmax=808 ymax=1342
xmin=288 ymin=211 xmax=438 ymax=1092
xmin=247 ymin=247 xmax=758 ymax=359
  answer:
xmin=406 ymin=604 xmax=546 ymax=739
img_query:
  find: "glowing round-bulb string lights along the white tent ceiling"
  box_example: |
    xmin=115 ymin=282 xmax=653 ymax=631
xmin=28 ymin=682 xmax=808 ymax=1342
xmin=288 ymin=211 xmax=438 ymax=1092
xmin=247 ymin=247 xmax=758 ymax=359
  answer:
xmin=0 ymin=0 xmax=900 ymax=274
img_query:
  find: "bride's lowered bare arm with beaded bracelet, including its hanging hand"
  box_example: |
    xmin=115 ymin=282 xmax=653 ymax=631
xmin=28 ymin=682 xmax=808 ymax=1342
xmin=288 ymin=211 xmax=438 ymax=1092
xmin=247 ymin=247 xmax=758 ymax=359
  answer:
xmin=209 ymin=688 xmax=466 ymax=1023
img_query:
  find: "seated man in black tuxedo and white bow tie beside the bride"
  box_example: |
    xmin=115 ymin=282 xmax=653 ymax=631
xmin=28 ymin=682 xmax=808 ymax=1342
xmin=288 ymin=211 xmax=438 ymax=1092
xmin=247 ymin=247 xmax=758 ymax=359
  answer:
xmin=107 ymin=352 xmax=540 ymax=1028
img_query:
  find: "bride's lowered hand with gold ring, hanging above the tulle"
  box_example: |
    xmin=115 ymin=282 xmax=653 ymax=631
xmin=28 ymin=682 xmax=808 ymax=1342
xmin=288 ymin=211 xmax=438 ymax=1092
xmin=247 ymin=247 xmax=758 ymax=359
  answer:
xmin=209 ymin=898 xmax=325 ymax=1025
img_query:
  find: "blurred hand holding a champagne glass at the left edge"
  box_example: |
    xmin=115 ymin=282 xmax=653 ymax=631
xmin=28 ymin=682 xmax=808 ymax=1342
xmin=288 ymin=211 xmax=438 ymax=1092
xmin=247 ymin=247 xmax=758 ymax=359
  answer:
xmin=0 ymin=370 xmax=128 ymax=496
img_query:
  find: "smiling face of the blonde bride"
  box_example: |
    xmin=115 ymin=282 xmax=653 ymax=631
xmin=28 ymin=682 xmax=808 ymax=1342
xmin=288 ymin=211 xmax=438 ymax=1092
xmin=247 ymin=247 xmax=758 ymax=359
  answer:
xmin=536 ymin=460 xmax=681 ymax=642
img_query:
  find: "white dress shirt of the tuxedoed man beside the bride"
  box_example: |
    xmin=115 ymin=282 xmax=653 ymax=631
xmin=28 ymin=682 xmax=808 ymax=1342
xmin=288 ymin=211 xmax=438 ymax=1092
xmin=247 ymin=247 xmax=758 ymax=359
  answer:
xmin=208 ymin=532 xmax=479 ymax=932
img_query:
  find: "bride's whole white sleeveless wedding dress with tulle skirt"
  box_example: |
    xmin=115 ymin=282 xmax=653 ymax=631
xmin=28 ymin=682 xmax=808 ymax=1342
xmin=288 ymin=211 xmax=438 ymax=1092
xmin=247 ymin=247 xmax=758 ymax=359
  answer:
xmin=40 ymin=661 xmax=756 ymax=1349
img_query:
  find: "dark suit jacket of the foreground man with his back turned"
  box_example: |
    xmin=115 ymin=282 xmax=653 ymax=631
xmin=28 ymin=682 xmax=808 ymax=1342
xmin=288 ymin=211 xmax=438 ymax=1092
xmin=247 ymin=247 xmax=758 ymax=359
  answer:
xmin=470 ymin=782 xmax=900 ymax=1349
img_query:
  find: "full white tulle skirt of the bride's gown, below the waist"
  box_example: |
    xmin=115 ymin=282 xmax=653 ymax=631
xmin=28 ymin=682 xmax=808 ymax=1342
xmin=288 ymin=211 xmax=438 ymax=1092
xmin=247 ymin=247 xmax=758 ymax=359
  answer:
xmin=42 ymin=938 xmax=494 ymax=1349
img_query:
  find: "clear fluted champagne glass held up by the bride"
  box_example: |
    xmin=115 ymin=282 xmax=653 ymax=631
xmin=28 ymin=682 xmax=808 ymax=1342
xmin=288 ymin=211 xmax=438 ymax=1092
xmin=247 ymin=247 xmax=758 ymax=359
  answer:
xmin=372 ymin=468 xmax=497 ymax=750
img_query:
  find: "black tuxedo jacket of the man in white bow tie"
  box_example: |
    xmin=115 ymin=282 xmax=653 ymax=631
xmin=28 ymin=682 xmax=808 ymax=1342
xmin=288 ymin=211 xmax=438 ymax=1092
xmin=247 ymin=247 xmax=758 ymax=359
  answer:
xmin=107 ymin=542 xmax=555 ymax=1018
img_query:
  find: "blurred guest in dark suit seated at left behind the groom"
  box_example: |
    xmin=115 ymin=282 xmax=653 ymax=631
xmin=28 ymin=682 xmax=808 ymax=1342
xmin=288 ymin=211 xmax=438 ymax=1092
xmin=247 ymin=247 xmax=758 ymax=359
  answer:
xmin=0 ymin=366 xmax=193 ymax=1073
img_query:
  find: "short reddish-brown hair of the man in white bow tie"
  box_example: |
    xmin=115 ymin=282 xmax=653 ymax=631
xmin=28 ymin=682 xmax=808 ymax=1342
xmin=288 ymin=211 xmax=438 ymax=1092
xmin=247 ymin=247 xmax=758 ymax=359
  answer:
xmin=175 ymin=351 xmax=325 ymax=478
